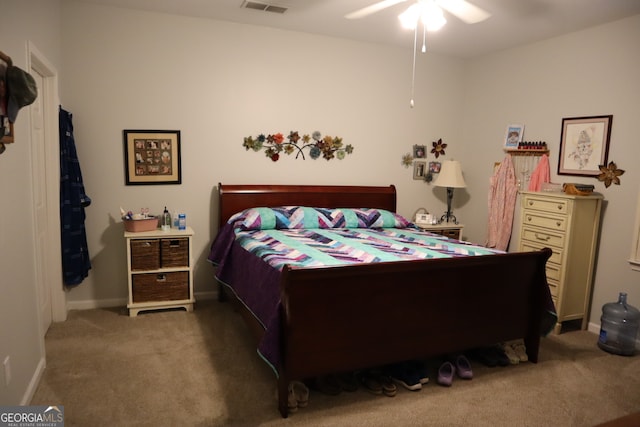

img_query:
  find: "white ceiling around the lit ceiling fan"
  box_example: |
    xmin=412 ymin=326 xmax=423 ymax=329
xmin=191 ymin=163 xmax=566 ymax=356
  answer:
xmin=79 ymin=0 xmax=640 ymax=58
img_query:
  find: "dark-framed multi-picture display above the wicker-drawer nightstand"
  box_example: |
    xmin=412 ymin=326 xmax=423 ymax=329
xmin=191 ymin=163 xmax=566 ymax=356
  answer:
xmin=123 ymin=130 xmax=182 ymax=185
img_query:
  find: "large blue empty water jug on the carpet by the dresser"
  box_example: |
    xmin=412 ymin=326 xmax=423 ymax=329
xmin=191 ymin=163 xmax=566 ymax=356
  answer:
xmin=598 ymin=292 xmax=640 ymax=356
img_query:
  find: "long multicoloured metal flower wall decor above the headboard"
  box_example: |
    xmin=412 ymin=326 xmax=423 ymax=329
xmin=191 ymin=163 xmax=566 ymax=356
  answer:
xmin=242 ymin=131 xmax=353 ymax=162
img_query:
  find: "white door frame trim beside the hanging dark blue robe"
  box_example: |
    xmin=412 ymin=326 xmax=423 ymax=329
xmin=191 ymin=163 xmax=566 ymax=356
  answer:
xmin=27 ymin=41 xmax=67 ymax=324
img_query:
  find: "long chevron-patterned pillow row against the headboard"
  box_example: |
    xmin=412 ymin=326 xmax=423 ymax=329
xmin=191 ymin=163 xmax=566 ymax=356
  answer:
xmin=229 ymin=206 xmax=410 ymax=230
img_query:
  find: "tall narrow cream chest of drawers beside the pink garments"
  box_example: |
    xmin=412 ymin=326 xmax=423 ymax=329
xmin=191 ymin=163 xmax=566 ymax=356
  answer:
xmin=519 ymin=192 xmax=602 ymax=334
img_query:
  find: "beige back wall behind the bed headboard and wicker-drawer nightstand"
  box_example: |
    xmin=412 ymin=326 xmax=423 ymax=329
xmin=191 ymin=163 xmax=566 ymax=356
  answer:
xmin=63 ymin=1 xmax=464 ymax=307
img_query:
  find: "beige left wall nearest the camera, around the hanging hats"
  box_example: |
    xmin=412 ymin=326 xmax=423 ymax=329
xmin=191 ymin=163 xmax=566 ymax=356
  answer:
xmin=0 ymin=0 xmax=61 ymax=405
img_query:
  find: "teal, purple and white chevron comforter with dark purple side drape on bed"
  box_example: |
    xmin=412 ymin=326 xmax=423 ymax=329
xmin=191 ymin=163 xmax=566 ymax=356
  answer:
xmin=209 ymin=206 xmax=500 ymax=373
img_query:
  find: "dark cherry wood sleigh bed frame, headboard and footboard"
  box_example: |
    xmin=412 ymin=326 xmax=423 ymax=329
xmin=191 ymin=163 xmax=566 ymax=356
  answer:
xmin=210 ymin=184 xmax=553 ymax=417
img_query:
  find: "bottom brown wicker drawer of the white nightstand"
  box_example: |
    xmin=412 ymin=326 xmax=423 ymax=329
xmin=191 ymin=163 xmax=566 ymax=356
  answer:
xmin=131 ymin=271 xmax=189 ymax=303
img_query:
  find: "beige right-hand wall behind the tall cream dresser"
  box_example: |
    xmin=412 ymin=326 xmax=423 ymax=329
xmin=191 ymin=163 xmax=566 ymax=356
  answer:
xmin=460 ymin=15 xmax=640 ymax=332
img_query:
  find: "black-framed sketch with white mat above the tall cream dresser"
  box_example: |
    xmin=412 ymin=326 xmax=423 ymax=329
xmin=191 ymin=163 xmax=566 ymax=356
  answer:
xmin=558 ymin=115 xmax=613 ymax=176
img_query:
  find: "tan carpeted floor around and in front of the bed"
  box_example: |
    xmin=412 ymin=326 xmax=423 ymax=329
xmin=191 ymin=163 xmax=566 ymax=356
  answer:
xmin=31 ymin=301 xmax=640 ymax=427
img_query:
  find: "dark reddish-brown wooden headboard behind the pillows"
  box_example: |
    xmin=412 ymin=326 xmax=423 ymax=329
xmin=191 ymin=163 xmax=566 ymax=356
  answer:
xmin=218 ymin=183 xmax=396 ymax=227
